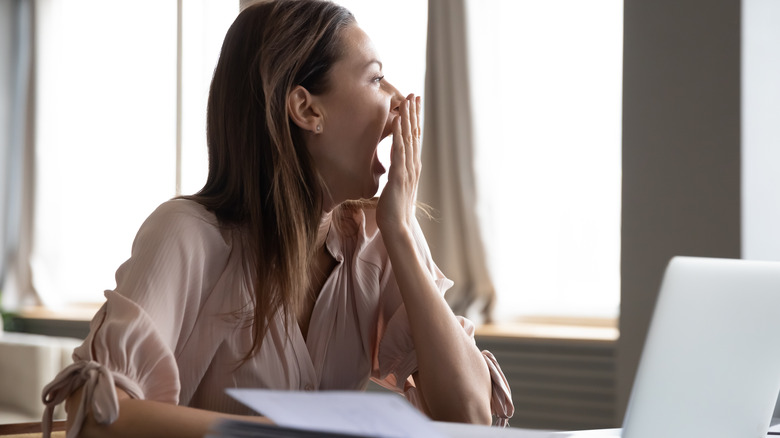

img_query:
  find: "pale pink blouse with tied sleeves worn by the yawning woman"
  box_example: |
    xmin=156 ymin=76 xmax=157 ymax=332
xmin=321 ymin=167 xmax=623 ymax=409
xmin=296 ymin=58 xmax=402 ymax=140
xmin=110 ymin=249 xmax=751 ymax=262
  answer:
xmin=43 ymin=200 xmax=514 ymax=437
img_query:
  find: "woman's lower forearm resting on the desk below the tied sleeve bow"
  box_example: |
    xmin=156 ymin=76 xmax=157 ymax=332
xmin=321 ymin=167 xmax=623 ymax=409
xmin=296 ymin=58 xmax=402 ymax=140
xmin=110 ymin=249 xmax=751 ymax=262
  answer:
xmin=65 ymin=388 xmax=271 ymax=438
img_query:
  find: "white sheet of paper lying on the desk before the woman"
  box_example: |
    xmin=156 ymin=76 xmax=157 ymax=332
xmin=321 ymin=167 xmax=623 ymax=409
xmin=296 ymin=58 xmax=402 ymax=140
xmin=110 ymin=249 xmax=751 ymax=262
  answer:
xmin=227 ymin=389 xmax=446 ymax=438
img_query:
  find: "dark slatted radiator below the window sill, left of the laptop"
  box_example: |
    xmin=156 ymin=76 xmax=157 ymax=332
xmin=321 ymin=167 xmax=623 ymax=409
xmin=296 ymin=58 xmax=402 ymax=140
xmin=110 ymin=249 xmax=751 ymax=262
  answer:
xmin=477 ymin=336 xmax=616 ymax=430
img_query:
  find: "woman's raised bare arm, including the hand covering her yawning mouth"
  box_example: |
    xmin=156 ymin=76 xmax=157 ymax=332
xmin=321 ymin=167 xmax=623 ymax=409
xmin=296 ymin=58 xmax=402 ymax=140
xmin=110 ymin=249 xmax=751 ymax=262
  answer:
xmin=377 ymin=96 xmax=492 ymax=424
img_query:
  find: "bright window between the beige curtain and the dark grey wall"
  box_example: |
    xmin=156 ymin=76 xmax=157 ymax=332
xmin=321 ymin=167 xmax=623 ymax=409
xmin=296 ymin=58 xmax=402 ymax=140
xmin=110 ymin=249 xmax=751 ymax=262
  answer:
xmin=468 ymin=0 xmax=623 ymax=320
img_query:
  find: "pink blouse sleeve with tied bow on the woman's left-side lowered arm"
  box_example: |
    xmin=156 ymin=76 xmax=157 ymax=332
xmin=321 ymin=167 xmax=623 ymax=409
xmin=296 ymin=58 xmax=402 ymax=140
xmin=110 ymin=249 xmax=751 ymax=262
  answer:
xmin=43 ymin=201 xmax=225 ymax=438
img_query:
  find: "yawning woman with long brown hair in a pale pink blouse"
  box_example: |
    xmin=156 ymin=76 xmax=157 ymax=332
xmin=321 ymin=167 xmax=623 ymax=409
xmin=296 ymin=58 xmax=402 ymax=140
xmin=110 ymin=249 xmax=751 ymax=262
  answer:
xmin=44 ymin=0 xmax=513 ymax=437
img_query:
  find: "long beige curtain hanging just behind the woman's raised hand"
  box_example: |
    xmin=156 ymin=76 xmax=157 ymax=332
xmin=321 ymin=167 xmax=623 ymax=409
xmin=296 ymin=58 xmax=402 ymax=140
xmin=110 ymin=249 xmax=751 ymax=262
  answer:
xmin=418 ymin=0 xmax=495 ymax=322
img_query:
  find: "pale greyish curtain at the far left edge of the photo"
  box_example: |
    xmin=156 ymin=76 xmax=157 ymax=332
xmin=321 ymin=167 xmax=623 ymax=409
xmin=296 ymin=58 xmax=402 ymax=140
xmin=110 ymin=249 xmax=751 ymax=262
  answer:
xmin=0 ymin=0 xmax=38 ymax=310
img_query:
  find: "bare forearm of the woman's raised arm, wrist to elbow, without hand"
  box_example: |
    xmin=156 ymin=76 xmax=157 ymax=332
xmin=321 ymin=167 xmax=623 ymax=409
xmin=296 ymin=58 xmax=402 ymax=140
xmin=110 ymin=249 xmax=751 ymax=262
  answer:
xmin=385 ymin=224 xmax=491 ymax=424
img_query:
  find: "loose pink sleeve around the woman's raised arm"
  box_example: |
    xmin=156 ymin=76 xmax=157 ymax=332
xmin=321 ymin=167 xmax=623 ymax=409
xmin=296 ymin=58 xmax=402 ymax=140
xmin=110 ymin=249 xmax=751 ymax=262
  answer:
xmin=372 ymin=217 xmax=514 ymax=426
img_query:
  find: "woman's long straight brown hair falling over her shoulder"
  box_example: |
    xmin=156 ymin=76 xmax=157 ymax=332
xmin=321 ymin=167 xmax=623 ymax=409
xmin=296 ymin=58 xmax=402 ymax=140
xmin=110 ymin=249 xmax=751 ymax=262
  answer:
xmin=188 ymin=0 xmax=355 ymax=360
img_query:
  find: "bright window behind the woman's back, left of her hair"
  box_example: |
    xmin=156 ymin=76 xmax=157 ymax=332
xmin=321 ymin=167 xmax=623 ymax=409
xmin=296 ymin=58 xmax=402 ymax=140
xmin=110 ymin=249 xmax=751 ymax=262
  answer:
xmin=32 ymin=0 xmax=238 ymax=307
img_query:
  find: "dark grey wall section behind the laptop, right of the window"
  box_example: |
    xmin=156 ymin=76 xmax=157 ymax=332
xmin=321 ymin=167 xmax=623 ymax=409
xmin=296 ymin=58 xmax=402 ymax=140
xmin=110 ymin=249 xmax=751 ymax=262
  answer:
xmin=616 ymin=0 xmax=741 ymax=423
